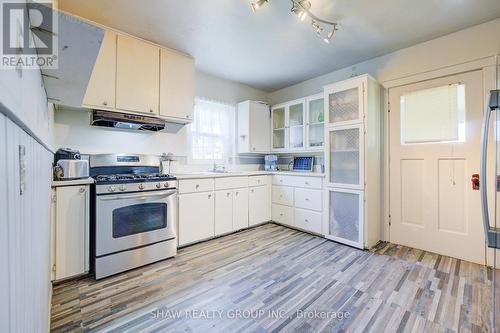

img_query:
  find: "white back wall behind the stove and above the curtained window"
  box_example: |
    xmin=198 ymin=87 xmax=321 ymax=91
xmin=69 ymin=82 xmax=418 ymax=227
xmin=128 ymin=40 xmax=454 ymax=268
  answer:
xmin=54 ymin=72 xmax=267 ymax=156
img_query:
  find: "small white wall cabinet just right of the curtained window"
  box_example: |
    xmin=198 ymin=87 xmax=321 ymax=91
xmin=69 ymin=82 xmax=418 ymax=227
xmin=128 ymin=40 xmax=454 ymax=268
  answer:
xmin=237 ymin=101 xmax=271 ymax=154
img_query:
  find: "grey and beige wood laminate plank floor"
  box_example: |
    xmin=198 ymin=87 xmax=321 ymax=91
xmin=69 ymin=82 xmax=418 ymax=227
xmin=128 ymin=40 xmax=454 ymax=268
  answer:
xmin=51 ymin=224 xmax=500 ymax=332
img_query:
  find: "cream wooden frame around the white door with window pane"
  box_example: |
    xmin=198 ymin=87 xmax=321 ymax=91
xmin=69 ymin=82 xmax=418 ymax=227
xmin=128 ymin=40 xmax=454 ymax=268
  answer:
xmin=381 ymin=55 xmax=500 ymax=255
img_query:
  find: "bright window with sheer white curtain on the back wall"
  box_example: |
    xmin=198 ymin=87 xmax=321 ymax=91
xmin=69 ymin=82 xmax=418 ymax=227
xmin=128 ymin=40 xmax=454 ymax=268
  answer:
xmin=189 ymin=98 xmax=235 ymax=161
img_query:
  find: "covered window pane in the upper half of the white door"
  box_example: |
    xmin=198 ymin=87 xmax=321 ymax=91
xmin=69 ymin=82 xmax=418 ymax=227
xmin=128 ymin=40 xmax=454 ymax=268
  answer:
xmin=400 ymin=83 xmax=465 ymax=144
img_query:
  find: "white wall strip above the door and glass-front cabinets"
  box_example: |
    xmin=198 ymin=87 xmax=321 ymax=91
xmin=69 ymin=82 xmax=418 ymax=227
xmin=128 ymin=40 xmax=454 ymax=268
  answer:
xmin=268 ymin=18 xmax=500 ymax=104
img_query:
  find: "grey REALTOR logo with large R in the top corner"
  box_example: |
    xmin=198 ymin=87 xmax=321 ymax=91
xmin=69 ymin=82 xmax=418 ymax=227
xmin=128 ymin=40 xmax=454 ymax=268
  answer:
xmin=0 ymin=0 xmax=58 ymax=69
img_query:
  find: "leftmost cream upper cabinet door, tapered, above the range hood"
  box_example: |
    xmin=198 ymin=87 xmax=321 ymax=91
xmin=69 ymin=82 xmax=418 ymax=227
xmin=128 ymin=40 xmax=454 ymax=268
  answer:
xmin=83 ymin=30 xmax=116 ymax=109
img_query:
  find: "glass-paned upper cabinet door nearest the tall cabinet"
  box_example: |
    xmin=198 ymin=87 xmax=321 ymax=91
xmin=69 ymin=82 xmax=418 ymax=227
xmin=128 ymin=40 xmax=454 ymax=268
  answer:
xmin=306 ymin=95 xmax=325 ymax=150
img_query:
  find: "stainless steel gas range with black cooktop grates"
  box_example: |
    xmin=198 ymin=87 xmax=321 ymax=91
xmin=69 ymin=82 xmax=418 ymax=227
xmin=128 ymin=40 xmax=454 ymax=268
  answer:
xmin=90 ymin=154 xmax=177 ymax=279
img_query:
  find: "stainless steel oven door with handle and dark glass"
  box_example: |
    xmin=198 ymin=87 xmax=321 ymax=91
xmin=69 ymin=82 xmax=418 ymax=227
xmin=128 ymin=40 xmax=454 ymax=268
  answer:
xmin=95 ymin=190 xmax=177 ymax=257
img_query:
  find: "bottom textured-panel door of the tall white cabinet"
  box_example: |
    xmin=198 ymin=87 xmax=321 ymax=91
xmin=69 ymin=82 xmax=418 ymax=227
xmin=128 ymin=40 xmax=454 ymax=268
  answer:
xmin=327 ymin=189 xmax=364 ymax=248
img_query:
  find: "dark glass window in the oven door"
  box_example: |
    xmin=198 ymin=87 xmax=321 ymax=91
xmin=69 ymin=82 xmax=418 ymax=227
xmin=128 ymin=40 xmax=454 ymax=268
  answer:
xmin=113 ymin=203 xmax=167 ymax=238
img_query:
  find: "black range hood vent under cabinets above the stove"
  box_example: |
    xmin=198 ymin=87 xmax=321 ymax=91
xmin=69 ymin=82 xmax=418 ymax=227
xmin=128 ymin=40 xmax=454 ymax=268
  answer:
xmin=90 ymin=110 xmax=165 ymax=132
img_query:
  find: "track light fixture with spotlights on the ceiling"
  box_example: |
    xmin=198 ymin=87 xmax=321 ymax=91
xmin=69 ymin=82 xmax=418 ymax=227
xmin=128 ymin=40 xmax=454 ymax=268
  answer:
xmin=251 ymin=0 xmax=338 ymax=43
